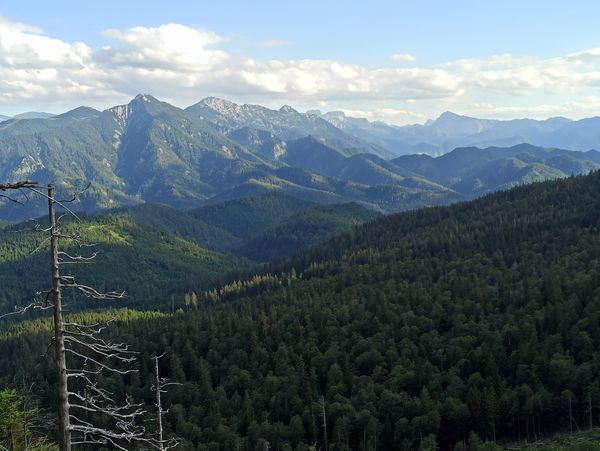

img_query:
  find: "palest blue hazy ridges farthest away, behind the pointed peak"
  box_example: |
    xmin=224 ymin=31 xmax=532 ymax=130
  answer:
xmin=7 ymin=97 xmax=600 ymax=158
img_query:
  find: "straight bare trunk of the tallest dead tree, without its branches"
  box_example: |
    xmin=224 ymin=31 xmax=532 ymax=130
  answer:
xmin=48 ymin=185 xmax=71 ymax=451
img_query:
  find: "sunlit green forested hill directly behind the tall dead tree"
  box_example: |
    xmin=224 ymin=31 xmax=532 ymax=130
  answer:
xmin=0 ymin=211 xmax=244 ymax=312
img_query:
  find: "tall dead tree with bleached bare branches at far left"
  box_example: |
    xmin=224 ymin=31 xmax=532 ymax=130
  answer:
xmin=0 ymin=180 xmax=150 ymax=451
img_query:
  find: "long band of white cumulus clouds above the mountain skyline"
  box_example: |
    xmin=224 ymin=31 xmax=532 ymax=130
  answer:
xmin=0 ymin=17 xmax=600 ymax=123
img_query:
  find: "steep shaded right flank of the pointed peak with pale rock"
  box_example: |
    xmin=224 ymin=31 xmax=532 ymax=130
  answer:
xmin=113 ymin=95 xmax=272 ymax=206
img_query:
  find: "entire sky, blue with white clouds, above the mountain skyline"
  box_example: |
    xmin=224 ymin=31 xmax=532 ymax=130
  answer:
xmin=0 ymin=0 xmax=600 ymax=125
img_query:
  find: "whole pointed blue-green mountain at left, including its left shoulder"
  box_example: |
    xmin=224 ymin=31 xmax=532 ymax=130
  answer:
xmin=0 ymin=95 xmax=264 ymax=221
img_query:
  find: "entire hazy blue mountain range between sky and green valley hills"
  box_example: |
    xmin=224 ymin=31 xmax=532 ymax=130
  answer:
xmin=0 ymin=95 xmax=600 ymax=219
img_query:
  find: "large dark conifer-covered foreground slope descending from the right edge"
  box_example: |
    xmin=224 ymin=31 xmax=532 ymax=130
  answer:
xmin=0 ymin=172 xmax=600 ymax=450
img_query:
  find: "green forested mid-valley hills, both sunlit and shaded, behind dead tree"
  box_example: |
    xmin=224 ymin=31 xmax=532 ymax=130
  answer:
xmin=0 ymin=193 xmax=379 ymax=314
